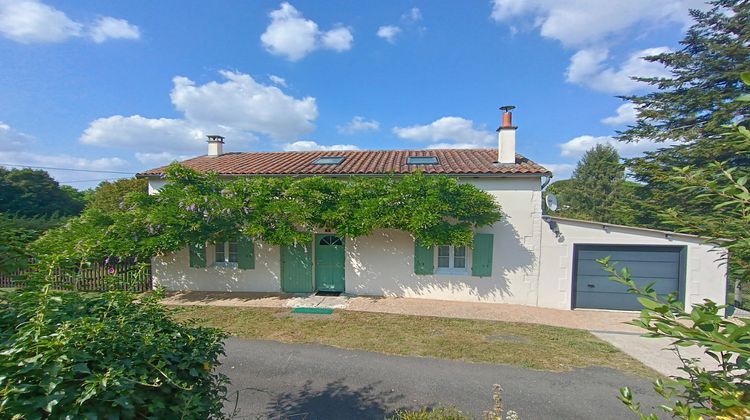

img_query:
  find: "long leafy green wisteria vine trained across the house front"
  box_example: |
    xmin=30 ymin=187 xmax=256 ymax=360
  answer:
xmin=33 ymin=165 xmax=502 ymax=264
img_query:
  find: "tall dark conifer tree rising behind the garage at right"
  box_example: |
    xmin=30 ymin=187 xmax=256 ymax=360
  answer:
xmin=618 ymin=0 xmax=750 ymax=227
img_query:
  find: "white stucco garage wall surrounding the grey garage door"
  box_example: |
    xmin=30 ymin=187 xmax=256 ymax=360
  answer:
xmin=539 ymin=218 xmax=727 ymax=309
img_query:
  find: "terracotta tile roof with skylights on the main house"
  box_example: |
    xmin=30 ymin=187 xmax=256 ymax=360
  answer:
xmin=138 ymin=149 xmax=550 ymax=177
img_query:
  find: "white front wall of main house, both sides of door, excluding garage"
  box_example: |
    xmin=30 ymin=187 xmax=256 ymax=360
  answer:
xmin=150 ymin=177 xmax=541 ymax=305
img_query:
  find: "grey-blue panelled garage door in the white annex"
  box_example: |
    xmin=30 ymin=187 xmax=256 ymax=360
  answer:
xmin=573 ymin=245 xmax=683 ymax=310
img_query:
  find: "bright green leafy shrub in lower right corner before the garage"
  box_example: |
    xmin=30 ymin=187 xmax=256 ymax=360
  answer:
xmin=599 ymin=258 xmax=750 ymax=420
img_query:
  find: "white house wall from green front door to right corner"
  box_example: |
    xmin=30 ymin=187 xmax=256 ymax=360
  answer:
xmin=346 ymin=177 xmax=541 ymax=305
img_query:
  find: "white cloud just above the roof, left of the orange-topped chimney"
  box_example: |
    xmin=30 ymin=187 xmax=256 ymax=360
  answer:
xmin=393 ymin=117 xmax=495 ymax=148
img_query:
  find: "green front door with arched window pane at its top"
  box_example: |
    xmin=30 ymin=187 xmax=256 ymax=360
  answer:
xmin=315 ymin=234 xmax=346 ymax=292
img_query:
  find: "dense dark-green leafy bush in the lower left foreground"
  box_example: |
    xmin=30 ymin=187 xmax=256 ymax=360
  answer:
xmin=0 ymin=286 xmax=226 ymax=419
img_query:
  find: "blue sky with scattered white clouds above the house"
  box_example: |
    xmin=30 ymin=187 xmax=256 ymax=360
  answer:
xmin=0 ymin=0 xmax=702 ymax=188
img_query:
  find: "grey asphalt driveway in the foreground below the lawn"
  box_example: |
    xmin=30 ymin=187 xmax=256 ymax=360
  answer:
xmin=220 ymin=338 xmax=659 ymax=420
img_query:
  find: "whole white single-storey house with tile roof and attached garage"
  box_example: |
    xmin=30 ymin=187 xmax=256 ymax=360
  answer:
xmin=138 ymin=109 xmax=726 ymax=310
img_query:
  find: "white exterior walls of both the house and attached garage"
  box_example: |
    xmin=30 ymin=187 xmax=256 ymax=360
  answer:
xmin=149 ymin=176 xmax=726 ymax=309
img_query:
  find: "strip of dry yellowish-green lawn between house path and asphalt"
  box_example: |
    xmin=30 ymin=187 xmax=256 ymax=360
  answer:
xmin=174 ymin=306 xmax=658 ymax=378
